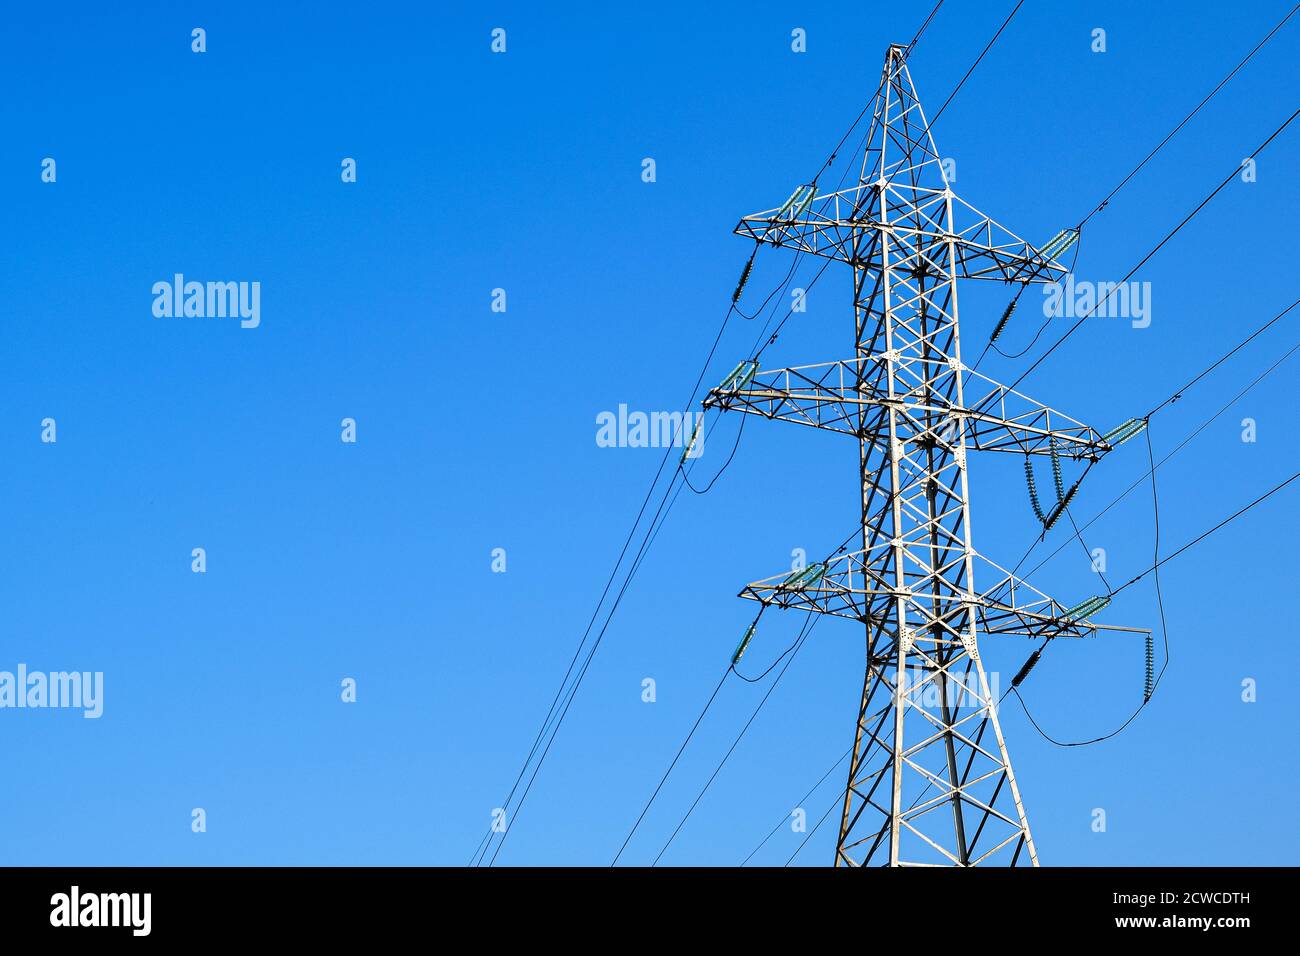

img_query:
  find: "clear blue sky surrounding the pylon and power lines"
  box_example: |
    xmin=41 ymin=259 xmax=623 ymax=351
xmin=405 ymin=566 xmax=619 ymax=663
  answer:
xmin=0 ymin=0 xmax=1300 ymax=865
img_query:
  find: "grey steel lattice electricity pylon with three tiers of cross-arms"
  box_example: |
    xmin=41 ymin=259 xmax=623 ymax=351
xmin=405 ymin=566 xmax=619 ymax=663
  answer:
xmin=705 ymin=46 xmax=1130 ymax=866
